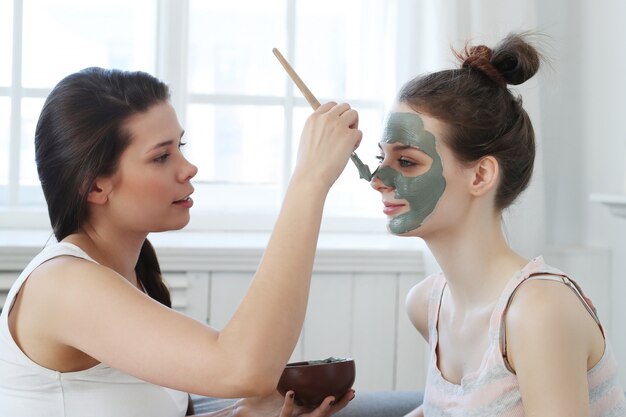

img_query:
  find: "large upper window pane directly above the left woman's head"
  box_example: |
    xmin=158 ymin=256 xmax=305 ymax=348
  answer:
xmin=23 ymin=0 xmax=157 ymax=88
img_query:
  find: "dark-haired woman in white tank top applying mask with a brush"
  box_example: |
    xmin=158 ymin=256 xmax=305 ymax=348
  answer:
xmin=0 ymin=68 xmax=361 ymax=417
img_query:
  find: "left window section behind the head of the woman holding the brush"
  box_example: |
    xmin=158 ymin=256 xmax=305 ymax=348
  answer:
xmin=0 ymin=0 xmax=157 ymax=210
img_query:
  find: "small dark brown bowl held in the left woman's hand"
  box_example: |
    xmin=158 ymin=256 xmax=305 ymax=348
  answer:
xmin=277 ymin=358 xmax=356 ymax=408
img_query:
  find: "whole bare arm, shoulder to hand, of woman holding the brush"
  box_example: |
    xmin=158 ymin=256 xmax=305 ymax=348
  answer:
xmin=18 ymin=103 xmax=361 ymax=397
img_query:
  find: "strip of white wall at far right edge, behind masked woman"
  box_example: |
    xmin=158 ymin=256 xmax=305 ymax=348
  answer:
xmin=573 ymin=0 xmax=626 ymax=385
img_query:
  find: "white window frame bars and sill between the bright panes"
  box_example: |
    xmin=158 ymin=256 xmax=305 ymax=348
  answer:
xmin=0 ymin=0 xmax=404 ymax=233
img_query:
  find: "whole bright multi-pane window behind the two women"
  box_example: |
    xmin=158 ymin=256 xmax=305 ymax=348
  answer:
xmin=0 ymin=0 xmax=394 ymax=231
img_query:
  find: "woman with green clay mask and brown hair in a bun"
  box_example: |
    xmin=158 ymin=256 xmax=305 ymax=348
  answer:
xmin=371 ymin=35 xmax=626 ymax=417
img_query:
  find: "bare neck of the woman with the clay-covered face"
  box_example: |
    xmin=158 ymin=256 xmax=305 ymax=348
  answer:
xmin=425 ymin=215 xmax=528 ymax=309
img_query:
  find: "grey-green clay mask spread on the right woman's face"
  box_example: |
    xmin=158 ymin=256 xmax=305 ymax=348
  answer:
xmin=374 ymin=113 xmax=446 ymax=234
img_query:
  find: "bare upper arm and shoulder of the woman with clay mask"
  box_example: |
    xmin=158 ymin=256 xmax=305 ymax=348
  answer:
xmin=506 ymin=281 xmax=604 ymax=417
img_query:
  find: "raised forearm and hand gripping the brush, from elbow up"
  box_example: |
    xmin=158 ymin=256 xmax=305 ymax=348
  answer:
xmin=214 ymin=105 xmax=361 ymax=389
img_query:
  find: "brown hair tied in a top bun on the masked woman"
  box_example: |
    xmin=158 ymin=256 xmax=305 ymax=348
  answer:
xmin=398 ymin=34 xmax=541 ymax=209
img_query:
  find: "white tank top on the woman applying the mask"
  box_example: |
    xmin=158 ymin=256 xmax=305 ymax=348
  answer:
xmin=0 ymin=242 xmax=187 ymax=417
